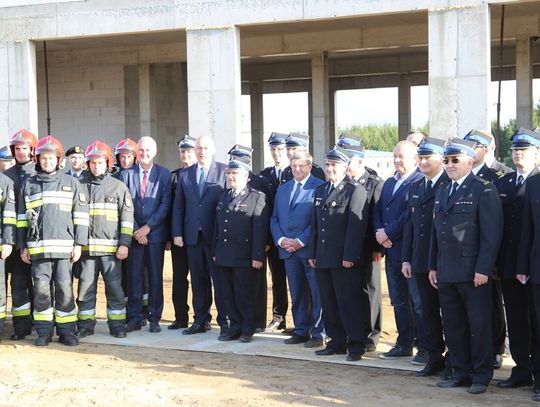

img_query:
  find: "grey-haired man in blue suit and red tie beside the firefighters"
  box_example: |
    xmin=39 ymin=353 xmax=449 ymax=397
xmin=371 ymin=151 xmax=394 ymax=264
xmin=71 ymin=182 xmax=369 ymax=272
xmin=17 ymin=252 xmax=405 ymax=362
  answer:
xmin=119 ymin=137 xmax=171 ymax=333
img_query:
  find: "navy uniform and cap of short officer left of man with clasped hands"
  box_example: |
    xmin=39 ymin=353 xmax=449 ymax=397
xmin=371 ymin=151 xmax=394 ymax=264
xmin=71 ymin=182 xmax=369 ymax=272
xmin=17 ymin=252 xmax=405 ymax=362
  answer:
xmin=213 ymin=160 xmax=269 ymax=342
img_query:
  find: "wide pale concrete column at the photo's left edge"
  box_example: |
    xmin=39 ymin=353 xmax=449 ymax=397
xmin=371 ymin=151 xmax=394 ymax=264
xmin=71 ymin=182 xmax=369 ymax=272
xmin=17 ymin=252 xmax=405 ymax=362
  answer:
xmin=0 ymin=41 xmax=38 ymax=144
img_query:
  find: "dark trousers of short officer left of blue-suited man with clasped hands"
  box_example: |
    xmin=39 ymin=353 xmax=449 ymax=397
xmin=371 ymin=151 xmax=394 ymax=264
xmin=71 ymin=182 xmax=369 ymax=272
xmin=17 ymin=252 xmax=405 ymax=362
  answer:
xmin=217 ymin=266 xmax=263 ymax=336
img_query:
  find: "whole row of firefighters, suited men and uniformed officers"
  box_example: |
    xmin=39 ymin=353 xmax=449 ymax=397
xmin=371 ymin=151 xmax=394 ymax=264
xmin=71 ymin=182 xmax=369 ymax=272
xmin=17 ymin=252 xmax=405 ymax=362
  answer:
xmin=0 ymin=123 xmax=540 ymax=401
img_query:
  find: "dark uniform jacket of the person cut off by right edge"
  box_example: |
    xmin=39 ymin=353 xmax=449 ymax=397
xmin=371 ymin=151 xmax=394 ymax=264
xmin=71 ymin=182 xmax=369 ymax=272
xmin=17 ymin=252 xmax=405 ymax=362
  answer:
xmin=514 ymin=173 xmax=540 ymax=284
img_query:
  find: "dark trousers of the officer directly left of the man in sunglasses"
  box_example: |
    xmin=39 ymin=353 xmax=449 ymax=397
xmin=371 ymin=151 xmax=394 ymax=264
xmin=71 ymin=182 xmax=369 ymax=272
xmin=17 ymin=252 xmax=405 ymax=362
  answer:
xmin=416 ymin=273 xmax=446 ymax=362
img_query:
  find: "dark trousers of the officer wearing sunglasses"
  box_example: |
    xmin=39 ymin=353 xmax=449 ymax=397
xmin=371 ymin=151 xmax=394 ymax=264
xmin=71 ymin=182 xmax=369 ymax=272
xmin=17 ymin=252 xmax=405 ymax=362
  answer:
xmin=438 ymin=280 xmax=493 ymax=385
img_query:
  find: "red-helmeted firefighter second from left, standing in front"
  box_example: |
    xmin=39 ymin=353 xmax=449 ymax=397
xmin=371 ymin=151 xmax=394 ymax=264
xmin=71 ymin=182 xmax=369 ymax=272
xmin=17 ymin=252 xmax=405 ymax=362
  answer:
xmin=17 ymin=136 xmax=88 ymax=346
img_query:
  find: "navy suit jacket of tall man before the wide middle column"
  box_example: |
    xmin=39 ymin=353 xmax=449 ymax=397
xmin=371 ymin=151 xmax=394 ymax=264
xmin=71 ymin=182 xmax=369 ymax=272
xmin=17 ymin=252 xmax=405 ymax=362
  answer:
xmin=172 ymin=161 xmax=226 ymax=245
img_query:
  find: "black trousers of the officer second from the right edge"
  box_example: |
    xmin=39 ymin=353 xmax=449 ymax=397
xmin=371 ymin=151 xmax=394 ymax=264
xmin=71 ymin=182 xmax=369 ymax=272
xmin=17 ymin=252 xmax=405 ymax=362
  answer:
xmin=501 ymin=278 xmax=537 ymax=380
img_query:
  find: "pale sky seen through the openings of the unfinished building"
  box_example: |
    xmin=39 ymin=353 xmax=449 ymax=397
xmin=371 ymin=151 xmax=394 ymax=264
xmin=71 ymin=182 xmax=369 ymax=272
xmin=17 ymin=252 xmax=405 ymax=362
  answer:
xmin=242 ymin=79 xmax=540 ymax=134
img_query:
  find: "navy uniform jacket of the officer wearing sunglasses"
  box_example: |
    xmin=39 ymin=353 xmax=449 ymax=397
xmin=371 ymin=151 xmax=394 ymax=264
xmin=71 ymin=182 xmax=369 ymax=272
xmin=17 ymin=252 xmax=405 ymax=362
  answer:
xmin=429 ymin=173 xmax=503 ymax=283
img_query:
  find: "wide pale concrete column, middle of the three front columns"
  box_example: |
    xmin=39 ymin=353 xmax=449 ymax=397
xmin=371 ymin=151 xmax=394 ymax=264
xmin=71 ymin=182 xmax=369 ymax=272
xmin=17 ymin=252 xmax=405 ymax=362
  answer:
xmin=186 ymin=27 xmax=243 ymax=161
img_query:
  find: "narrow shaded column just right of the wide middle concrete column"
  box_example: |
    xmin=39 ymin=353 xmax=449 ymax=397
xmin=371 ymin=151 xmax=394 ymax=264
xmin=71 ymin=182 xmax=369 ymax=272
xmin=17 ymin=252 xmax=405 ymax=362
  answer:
xmin=249 ymin=82 xmax=265 ymax=172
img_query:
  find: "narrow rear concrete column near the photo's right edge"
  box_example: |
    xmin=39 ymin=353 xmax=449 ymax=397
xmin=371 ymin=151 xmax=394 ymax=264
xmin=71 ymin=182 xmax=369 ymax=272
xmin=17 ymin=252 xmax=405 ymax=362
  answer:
xmin=516 ymin=37 xmax=533 ymax=129
